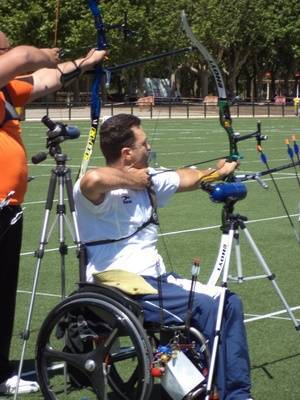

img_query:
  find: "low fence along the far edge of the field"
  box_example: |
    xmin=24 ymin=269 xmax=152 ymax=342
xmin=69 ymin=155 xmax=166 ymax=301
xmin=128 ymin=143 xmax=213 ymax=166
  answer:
xmin=24 ymin=102 xmax=298 ymax=120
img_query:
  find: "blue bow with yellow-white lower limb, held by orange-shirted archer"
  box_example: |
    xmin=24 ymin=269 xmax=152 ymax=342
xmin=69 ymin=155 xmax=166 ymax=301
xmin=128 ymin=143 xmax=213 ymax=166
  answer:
xmin=77 ymin=0 xmax=107 ymax=178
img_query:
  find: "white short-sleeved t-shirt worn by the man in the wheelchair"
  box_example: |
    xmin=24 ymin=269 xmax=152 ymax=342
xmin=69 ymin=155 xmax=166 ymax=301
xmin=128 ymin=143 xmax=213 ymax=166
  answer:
xmin=74 ymin=169 xmax=179 ymax=281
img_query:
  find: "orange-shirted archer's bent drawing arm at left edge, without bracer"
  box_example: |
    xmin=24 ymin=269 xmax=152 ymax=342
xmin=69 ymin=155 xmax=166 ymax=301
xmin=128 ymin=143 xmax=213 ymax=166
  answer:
xmin=0 ymin=46 xmax=59 ymax=87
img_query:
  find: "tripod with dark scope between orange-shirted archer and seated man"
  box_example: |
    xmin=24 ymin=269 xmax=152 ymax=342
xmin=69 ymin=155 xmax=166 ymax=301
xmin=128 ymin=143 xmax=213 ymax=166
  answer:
xmin=14 ymin=117 xmax=81 ymax=399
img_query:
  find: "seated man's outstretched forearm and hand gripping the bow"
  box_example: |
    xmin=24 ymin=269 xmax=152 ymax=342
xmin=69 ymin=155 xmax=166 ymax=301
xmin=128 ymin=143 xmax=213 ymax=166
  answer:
xmin=176 ymin=160 xmax=238 ymax=192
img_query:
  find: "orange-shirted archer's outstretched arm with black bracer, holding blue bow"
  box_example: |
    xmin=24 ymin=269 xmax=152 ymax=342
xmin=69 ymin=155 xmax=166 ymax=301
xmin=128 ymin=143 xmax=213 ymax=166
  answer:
xmin=29 ymin=49 xmax=107 ymax=101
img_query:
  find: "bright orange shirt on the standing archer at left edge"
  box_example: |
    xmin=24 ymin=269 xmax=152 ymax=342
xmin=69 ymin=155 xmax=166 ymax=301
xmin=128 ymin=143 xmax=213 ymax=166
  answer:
xmin=0 ymin=80 xmax=33 ymax=205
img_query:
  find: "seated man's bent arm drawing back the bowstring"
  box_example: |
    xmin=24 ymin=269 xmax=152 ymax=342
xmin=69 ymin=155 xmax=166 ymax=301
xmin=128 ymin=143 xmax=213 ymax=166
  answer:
xmin=80 ymin=167 xmax=150 ymax=204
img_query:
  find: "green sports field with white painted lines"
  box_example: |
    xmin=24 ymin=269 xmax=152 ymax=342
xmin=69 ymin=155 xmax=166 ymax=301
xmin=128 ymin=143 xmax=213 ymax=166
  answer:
xmin=8 ymin=115 xmax=300 ymax=400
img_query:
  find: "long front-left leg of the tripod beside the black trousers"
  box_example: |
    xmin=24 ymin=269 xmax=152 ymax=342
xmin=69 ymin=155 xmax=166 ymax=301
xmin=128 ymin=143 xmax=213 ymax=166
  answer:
xmin=14 ymin=170 xmax=57 ymax=400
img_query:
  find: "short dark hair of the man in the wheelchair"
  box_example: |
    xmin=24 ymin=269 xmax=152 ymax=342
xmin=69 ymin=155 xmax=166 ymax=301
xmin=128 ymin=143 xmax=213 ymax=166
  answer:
xmin=100 ymin=114 xmax=141 ymax=164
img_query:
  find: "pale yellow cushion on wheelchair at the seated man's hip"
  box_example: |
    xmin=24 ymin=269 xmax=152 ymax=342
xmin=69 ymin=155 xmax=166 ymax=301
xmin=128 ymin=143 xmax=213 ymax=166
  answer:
xmin=93 ymin=269 xmax=157 ymax=296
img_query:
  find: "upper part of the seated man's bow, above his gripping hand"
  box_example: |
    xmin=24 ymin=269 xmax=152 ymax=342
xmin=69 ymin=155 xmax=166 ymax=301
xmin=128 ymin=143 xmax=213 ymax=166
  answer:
xmin=181 ymin=11 xmax=240 ymax=161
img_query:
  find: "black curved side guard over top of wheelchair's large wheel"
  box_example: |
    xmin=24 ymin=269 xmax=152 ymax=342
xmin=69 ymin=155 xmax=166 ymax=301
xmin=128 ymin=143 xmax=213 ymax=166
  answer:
xmin=77 ymin=282 xmax=144 ymax=318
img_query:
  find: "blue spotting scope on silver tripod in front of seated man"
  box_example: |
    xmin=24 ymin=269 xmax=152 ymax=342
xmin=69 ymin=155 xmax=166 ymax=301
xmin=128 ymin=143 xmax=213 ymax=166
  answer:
xmin=198 ymin=180 xmax=300 ymax=400
